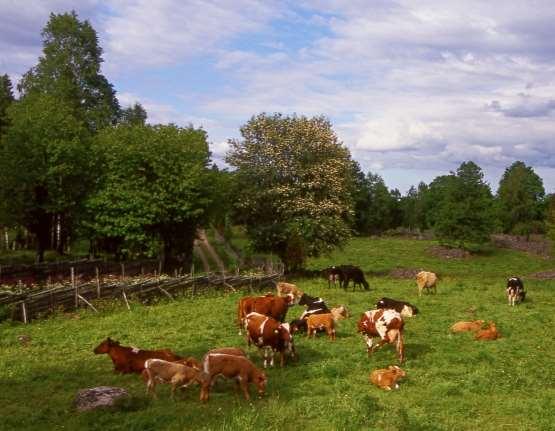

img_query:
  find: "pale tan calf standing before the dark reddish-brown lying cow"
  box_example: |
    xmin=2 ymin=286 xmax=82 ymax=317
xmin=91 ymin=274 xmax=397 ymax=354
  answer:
xmin=143 ymin=359 xmax=203 ymax=399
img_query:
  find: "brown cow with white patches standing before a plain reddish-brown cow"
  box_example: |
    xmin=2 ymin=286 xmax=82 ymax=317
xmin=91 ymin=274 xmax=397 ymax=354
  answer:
xmin=245 ymin=312 xmax=296 ymax=368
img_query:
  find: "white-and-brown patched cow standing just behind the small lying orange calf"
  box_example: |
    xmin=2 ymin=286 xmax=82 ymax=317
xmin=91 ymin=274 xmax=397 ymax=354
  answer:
xmin=357 ymin=309 xmax=405 ymax=363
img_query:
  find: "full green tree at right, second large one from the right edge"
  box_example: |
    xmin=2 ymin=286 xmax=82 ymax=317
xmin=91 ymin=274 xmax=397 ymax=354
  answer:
xmin=430 ymin=162 xmax=493 ymax=248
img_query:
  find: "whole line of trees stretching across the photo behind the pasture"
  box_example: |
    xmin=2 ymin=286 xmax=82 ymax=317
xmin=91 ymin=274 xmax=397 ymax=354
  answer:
xmin=0 ymin=12 xmax=555 ymax=270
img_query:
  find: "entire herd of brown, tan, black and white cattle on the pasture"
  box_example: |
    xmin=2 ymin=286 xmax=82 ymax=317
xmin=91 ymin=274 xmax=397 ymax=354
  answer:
xmin=94 ymin=265 xmax=526 ymax=402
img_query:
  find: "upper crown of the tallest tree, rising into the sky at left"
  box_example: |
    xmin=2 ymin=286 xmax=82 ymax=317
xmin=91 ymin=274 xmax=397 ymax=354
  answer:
xmin=18 ymin=11 xmax=119 ymax=131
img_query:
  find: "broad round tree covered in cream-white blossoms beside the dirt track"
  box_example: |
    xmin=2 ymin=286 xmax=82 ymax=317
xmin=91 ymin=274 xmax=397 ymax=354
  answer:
xmin=226 ymin=114 xmax=352 ymax=270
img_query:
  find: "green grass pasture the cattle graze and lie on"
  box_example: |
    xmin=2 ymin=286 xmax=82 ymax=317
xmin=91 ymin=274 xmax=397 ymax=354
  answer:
xmin=0 ymin=239 xmax=555 ymax=431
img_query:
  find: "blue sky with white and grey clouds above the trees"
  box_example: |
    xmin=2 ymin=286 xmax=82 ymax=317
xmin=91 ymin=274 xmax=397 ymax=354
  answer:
xmin=0 ymin=0 xmax=555 ymax=193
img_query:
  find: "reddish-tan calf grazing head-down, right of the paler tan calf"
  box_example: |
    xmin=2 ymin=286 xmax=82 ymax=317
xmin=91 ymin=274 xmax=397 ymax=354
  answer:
xmin=200 ymin=352 xmax=268 ymax=402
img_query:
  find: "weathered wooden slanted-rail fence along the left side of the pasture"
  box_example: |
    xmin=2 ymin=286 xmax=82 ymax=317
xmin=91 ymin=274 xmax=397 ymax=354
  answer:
xmin=0 ymin=273 xmax=281 ymax=323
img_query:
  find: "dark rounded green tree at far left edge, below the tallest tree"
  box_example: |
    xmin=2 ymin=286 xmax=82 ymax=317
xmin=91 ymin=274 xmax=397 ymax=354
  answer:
xmin=0 ymin=95 xmax=91 ymax=262
